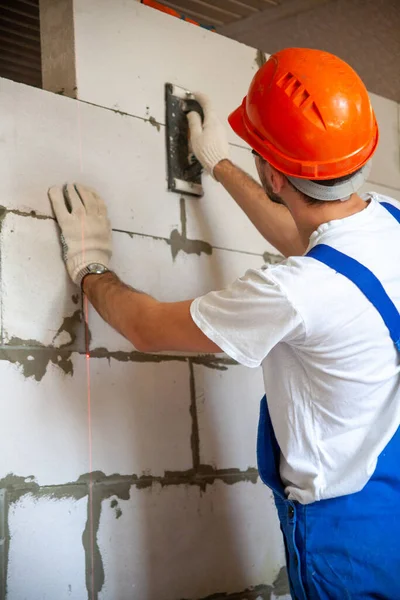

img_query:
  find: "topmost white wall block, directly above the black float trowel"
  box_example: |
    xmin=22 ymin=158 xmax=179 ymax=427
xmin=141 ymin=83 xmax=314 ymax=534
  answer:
xmin=74 ymin=0 xmax=257 ymax=145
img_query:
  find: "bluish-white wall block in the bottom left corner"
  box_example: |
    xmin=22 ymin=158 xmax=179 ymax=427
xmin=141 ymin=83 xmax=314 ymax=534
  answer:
xmin=7 ymin=494 xmax=87 ymax=600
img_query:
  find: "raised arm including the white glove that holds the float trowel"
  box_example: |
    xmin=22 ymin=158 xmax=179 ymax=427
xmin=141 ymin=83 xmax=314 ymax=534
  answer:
xmin=188 ymin=94 xmax=305 ymax=256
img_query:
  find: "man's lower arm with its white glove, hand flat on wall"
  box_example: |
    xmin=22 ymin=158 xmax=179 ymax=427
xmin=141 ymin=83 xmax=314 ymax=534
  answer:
xmin=49 ymin=184 xmax=221 ymax=352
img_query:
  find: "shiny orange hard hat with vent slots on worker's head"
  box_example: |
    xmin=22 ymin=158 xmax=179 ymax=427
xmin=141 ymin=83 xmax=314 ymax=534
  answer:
xmin=228 ymin=48 xmax=379 ymax=180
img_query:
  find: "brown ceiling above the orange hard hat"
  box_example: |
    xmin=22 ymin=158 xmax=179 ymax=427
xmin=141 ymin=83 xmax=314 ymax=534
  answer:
xmin=165 ymin=0 xmax=400 ymax=102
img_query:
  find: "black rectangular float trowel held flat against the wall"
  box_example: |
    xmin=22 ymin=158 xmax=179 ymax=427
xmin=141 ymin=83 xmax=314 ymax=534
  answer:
xmin=165 ymin=83 xmax=204 ymax=196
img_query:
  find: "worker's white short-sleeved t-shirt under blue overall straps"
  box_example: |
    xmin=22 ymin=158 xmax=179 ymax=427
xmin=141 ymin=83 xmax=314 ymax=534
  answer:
xmin=191 ymin=193 xmax=400 ymax=504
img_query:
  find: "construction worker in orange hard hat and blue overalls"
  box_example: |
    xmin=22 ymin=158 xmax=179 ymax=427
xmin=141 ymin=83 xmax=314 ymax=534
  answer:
xmin=49 ymin=48 xmax=400 ymax=600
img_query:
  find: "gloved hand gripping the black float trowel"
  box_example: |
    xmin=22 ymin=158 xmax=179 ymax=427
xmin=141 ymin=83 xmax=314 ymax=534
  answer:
xmin=187 ymin=93 xmax=230 ymax=177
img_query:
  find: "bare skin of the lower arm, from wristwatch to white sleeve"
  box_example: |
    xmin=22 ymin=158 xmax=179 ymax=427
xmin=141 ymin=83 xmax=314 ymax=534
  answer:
xmin=82 ymin=272 xmax=222 ymax=353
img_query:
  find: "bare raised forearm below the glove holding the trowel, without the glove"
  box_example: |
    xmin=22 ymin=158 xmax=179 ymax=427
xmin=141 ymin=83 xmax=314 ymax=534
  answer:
xmin=214 ymin=160 xmax=305 ymax=256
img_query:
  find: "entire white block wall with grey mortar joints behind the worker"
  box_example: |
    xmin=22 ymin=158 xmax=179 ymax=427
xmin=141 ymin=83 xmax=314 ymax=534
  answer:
xmin=0 ymin=0 xmax=400 ymax=600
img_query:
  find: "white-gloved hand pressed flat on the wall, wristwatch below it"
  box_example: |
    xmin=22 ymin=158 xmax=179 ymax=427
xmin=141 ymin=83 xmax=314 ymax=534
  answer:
xmin=48 ymin=184 xmax=112 ymax=285
